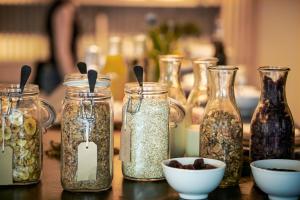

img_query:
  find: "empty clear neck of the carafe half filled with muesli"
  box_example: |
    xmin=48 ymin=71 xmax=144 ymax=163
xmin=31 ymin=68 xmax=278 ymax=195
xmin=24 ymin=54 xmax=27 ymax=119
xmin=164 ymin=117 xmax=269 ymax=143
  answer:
xmin=208 ymin=66 xmax=237 ymax=102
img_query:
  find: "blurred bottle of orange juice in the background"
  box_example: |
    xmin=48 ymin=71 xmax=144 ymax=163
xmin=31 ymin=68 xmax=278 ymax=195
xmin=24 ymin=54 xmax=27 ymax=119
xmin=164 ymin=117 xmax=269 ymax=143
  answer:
xmin=101 ymin=37 xmax=128 ymax=101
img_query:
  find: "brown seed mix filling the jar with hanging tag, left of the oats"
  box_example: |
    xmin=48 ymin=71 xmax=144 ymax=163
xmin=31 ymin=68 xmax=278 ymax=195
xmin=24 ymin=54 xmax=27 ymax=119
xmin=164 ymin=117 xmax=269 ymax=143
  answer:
xmin=61 ymin=100 xmax=113 ymax=191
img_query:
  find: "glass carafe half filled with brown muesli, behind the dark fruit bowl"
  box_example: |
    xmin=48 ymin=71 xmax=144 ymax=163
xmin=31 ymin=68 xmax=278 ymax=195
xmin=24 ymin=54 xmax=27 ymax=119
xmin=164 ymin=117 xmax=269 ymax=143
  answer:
xmin=200 ymin=66 xmax=243 ymax=187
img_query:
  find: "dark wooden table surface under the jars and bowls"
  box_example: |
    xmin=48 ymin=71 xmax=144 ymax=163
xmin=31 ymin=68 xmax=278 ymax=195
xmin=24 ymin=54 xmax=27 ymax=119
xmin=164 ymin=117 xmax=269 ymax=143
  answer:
xmin=0 ymin=129 xmax=268 ymax=200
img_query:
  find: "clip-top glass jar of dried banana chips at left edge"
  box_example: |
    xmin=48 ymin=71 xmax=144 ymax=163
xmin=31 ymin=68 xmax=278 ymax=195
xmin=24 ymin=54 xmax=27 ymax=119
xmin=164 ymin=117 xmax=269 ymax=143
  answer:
xmin=0 ymin=84 xmax=56 ymax=185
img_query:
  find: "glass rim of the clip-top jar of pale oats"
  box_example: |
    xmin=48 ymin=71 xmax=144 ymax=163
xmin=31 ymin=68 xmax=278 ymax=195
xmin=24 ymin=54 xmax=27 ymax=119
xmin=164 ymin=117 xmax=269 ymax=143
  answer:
xmin=124 ymin=82 xmax=168 ymax=94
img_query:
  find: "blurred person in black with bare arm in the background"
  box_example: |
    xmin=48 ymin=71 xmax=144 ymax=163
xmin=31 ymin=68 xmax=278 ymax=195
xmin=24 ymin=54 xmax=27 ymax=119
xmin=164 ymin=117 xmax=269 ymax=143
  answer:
xmin=35 ymin=0 xmax=79 ymax=96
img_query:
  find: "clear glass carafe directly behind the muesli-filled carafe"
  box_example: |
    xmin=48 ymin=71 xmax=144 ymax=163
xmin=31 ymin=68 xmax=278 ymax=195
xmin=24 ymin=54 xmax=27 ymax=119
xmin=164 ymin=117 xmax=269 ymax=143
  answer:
xmin=185 ymin=58 xmax=218 ymax=156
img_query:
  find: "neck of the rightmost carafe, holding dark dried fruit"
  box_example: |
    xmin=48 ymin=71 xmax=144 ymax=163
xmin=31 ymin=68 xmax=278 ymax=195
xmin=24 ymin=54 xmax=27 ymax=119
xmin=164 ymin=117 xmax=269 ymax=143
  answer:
xmin=259 ymin=68 xmax=289 ymax=106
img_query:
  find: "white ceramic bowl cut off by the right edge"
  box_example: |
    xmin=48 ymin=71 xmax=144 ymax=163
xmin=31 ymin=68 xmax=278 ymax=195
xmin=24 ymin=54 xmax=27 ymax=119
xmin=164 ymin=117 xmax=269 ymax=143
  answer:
xmin=250 ymin=159 xmax=300 ymax=200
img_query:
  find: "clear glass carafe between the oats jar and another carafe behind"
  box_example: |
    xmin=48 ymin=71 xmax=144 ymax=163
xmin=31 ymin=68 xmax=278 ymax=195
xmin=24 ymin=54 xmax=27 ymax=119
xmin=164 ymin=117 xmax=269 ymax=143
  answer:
xmin=159 ymin=55 xmax=186 ymax=158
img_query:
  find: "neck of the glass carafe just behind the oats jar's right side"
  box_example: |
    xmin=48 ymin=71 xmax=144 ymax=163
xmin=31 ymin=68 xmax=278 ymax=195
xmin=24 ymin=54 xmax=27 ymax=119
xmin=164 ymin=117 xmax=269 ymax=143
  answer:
xmin=159 ymin=56 xmax=182 ymax=87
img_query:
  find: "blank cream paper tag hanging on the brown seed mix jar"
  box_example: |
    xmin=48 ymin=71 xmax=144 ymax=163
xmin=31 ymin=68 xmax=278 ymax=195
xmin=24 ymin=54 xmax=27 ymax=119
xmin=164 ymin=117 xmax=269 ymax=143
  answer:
xmin=76 ymin=142 xmax=97 ymax=181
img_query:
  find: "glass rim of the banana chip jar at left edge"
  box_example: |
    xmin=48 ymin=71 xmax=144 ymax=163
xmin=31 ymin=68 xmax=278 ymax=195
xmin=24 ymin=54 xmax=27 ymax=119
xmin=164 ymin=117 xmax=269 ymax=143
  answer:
xmin=0 ymin=83 xmax=39 ymax=96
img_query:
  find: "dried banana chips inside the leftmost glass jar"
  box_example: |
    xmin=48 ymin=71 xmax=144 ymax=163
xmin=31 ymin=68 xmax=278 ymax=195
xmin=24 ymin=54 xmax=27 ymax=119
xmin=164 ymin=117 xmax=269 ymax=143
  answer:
xmin=0 ymin=109 xmax=41 ymax=183
